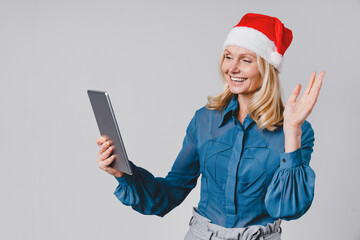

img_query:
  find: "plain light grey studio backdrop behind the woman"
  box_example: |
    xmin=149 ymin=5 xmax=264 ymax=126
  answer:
xmin=0 ymin=0 xmax=360 ymax=240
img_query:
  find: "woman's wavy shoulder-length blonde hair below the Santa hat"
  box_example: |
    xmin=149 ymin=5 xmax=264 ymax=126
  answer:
xmin=206 ymin=54 xmax=284 ymax=131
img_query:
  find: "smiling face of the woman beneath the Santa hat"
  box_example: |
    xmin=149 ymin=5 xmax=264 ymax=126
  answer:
xmin=221 ymin=46 xmax=262 ymax=97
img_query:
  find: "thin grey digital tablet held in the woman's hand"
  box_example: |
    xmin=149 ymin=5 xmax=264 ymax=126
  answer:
xmin=87 ymin=90 xmax=132 ymax=175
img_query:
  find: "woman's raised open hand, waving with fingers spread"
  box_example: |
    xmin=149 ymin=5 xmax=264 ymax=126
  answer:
xmin=284 ymin=72 xmax=325 ymax=128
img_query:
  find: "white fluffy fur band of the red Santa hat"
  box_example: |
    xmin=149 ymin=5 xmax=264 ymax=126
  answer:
xmin=223 ymin=27 xmax=283 ymax=70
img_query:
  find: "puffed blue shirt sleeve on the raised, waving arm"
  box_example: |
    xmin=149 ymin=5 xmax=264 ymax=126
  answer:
xmin=265 ymin=121 xmax=315 ymax=220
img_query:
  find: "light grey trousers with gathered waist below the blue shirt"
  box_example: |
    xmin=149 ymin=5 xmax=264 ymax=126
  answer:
xmin=185 ymin=208 xmax=281 ymax=240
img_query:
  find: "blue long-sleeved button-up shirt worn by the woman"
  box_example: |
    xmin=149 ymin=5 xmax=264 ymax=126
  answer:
xmin=115 ymin=96 xmax=315 ymax=228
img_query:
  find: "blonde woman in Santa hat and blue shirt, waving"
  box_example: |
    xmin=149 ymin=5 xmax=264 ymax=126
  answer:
xmin=97 ymin=13 xmax=324 ymax=239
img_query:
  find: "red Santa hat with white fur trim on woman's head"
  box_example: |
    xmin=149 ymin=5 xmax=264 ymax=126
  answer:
xmin=224 ymin=13 xmax=293 ymax=70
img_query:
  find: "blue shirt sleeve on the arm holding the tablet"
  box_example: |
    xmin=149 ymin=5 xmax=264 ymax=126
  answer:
xmin=114 ymin=114 xmax=200 ymax=216
